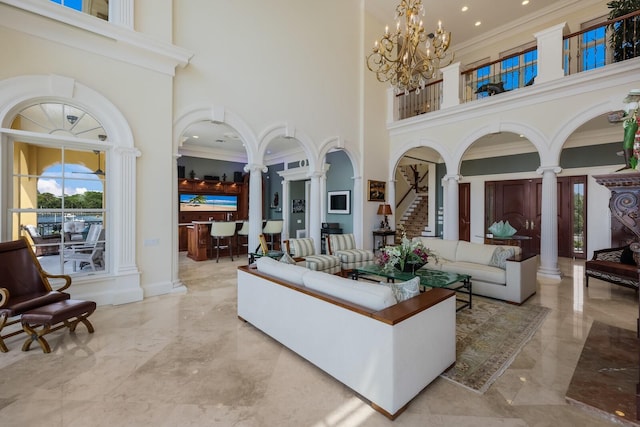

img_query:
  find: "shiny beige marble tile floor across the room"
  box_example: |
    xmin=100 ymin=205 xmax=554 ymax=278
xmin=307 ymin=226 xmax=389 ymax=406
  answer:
xmin=0 ymin=254 xmax=638 ymax=427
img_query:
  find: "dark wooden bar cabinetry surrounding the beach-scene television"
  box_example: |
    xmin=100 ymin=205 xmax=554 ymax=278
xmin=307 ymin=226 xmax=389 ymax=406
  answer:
xmin=178 ymin=174 xmax=249 ymax=251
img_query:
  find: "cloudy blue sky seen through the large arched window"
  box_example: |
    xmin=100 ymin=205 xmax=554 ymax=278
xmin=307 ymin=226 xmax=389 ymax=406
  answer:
xmin=38 ymin=164 xmax=104 ymax=197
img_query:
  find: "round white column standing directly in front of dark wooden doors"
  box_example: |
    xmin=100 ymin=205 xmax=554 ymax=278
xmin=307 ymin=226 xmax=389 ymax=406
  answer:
xmin=536 ymin=166 xmax=562 ymax=279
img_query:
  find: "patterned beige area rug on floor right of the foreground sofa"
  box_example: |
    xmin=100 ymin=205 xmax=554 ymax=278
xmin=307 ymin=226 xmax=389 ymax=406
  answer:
xmin=441 ymin=298 xmax=550 ymax=393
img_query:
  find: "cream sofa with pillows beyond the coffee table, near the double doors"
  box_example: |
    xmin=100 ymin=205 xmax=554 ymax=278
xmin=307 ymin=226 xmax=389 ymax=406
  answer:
xmin=413 ymin=237 xmax=538 ymax=304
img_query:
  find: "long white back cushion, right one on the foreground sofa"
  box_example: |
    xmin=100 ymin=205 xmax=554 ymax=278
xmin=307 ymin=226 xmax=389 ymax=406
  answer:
xmin=303 ymin=271 xmax=396 ymax=310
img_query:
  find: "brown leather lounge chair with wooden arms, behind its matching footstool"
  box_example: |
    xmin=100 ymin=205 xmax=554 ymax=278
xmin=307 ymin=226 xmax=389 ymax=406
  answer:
xmin=0 ymin=237 xmax=71 ymax=353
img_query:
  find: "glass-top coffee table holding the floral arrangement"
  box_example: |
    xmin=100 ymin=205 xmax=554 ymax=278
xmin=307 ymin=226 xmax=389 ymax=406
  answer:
xmin=352 ymin=264 xmax=473 ymax=311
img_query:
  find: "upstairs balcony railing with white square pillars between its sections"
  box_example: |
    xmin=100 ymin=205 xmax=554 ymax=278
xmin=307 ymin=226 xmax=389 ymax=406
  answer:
xmin=388 ymin=10 xmax=640 ymax=122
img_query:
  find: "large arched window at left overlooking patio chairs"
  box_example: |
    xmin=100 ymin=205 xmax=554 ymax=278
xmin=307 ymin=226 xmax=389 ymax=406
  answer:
xmin=10 ymin=102 xmax=110 ymax=274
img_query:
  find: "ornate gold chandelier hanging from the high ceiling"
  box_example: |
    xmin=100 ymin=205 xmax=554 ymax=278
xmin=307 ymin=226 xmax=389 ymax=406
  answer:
xmin=367 ymin=0 xmax=453 ymax=94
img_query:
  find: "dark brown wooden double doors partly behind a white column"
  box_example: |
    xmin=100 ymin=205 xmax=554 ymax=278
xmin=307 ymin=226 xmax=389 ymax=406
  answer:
xmin=485 ymin=177 xmax=586 ymax=257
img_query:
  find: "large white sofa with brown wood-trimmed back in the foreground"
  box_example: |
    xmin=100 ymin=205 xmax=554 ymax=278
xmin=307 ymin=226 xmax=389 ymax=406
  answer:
xmin=238 ymin=257 xmax=456 ymax=419
